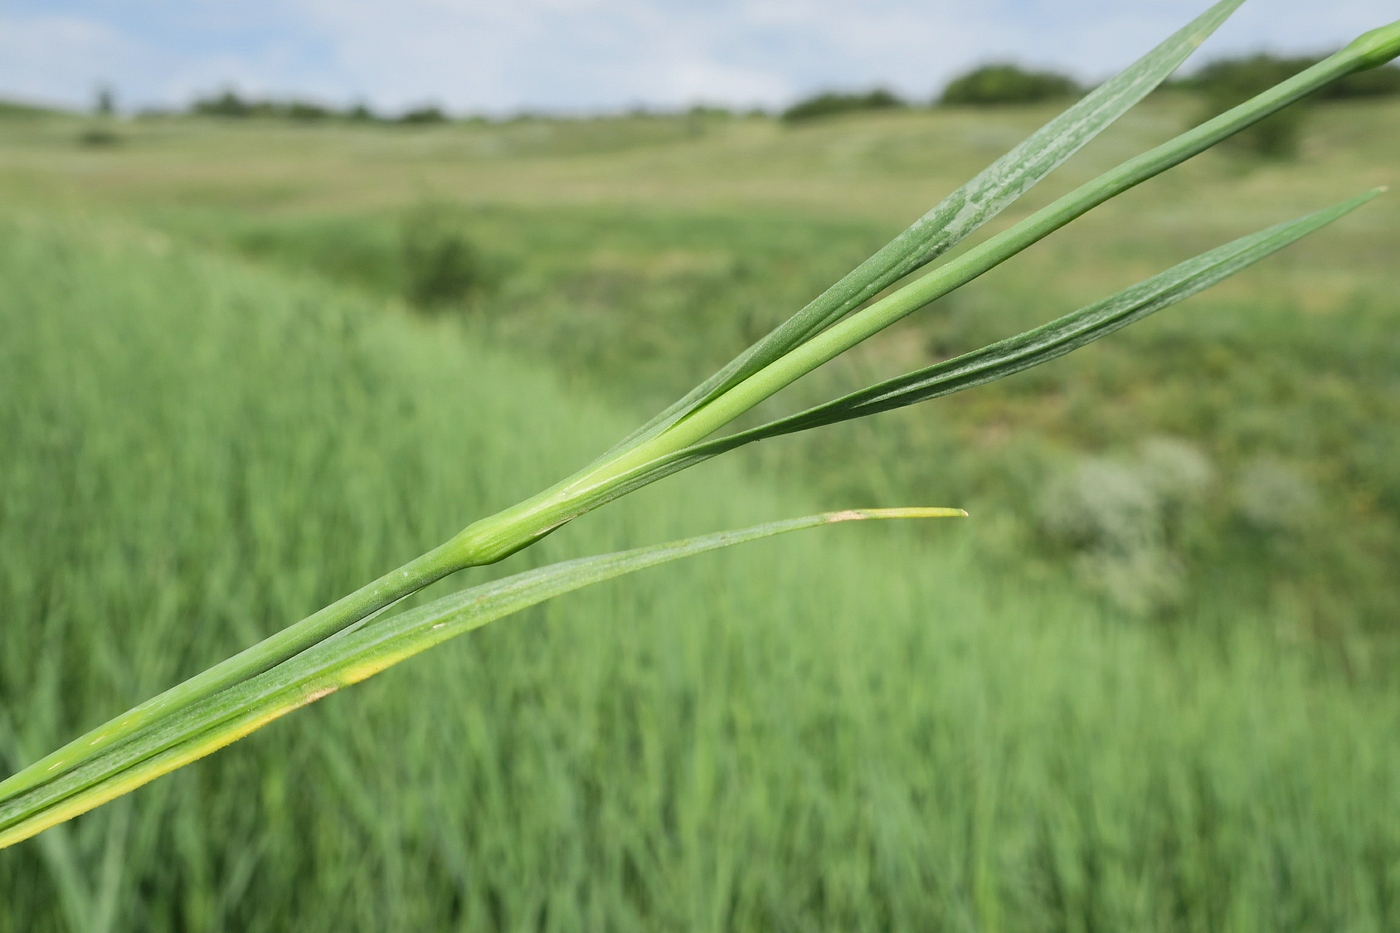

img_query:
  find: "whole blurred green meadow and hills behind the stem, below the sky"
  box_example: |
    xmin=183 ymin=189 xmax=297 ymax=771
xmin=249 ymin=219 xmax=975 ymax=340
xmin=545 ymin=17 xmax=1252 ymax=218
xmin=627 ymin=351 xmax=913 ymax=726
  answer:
xmin=0 ymin=92 xmax=1400 ymax=932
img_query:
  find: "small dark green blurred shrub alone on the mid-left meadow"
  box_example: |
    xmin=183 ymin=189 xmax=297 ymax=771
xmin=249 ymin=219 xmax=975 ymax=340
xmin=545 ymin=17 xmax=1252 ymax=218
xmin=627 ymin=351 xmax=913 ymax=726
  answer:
xmin=402 ymin=205 xmax=484 ymax=308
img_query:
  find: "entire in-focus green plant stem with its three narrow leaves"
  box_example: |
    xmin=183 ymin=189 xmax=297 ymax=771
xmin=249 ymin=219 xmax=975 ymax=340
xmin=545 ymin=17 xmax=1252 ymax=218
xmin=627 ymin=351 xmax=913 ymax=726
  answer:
xmin=0 ymin=0 xmax=1400 ymax=846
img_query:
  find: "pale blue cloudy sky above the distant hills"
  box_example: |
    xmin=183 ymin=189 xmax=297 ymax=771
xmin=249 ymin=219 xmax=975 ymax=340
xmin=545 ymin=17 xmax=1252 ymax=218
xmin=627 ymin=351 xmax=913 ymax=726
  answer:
xmin=0 ymin=0 xmax=1400 ymax=113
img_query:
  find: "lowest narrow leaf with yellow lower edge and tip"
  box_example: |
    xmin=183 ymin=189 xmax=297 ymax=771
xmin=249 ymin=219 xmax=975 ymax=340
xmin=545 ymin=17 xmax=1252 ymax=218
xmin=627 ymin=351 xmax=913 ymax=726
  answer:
xmin=0 ymin=509 xmax=966 ymax=848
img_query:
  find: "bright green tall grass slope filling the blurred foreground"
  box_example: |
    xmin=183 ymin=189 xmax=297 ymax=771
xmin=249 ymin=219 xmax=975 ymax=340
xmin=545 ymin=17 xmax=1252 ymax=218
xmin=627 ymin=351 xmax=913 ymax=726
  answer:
xmin=8 ymin=183 xmax=1400 ymax=932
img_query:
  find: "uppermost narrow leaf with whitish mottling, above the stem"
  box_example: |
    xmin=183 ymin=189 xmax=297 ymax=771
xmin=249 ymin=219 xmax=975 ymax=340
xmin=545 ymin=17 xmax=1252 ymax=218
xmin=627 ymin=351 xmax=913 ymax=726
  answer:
xmin=609 ymin=0 xmax=1243 ymax=454
